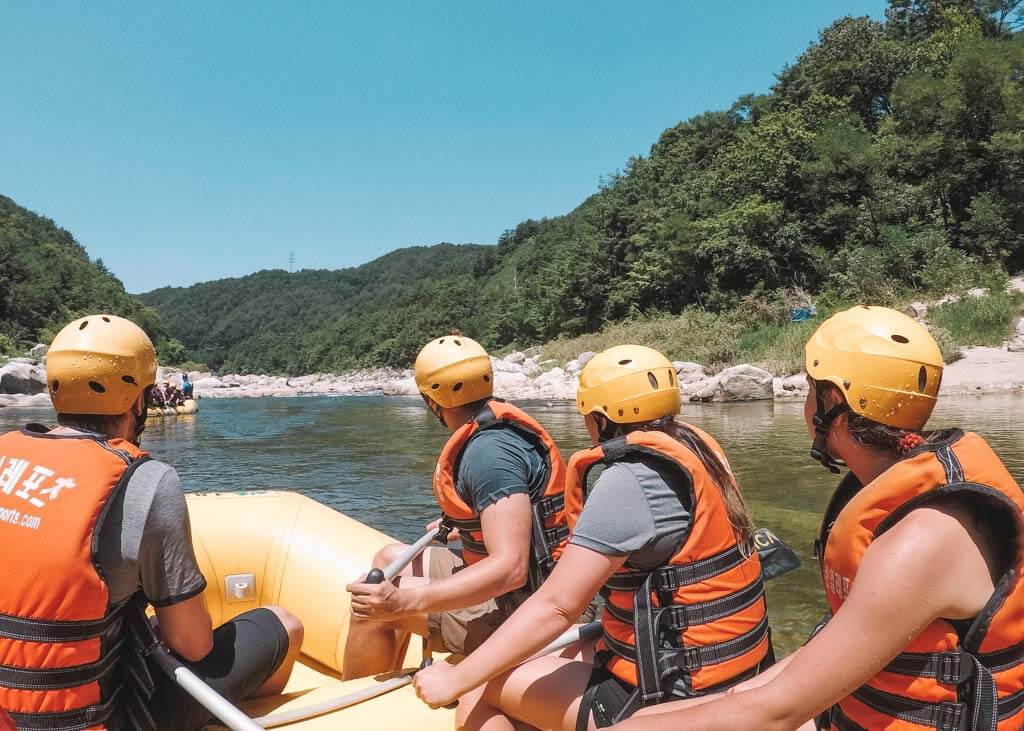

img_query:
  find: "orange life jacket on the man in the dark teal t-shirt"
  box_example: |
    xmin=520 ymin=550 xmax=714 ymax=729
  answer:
xmin=433 ymin=398 xmax=568 ymax=589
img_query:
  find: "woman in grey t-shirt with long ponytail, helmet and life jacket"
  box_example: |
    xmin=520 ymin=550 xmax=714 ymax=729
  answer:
xmin=414 ymin=345 xmax=773 ymax=731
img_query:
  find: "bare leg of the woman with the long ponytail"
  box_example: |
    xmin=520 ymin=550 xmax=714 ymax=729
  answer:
xmin=457 ymin=641 xmax=594 ymax=731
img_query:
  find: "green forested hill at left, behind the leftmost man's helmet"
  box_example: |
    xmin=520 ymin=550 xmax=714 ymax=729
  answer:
xmin=0 ymin=196 xmax=182 ymax=360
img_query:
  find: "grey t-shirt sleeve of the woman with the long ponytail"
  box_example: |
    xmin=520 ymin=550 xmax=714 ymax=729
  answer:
xmin=569 ymin=456 xmax=692 ymax=569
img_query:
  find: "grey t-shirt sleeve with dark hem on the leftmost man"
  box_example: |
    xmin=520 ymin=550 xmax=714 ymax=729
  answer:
xmin=97 ymin=460 xmax=206 ymax=607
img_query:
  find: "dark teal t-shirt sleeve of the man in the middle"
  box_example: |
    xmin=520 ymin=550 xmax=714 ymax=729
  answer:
xmin=456 ymin=427 xmax=548 ymax=515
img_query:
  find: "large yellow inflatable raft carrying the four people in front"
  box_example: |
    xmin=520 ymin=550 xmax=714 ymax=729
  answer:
xmin=188 ymin=492 xmax=455 ymax=731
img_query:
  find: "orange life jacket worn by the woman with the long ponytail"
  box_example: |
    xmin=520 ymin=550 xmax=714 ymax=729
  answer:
xmin=565 ymin=425 xmax=771 ymax=703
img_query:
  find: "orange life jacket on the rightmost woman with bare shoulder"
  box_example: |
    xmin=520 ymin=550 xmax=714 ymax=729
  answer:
xmin=818 ymin=430 xmax=1024 ymax=731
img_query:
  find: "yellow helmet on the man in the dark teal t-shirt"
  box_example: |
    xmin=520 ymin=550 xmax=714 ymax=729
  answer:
xmin=414 ymin=334 xmax=495 ymax=409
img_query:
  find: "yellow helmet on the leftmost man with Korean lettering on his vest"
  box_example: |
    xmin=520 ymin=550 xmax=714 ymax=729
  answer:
xmin=46 ymin=314 xmax=157 ymax=416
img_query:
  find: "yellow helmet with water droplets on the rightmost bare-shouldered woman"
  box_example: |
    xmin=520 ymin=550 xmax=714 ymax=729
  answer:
xmin=806 ymin=306 xmax=943 ymax=431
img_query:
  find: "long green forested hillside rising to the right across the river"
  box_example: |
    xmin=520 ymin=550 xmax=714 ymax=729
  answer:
xmin=143 ymin=0 xmax=1024 ymax=372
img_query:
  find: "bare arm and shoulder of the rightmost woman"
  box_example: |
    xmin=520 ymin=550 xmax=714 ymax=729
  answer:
xmin=615 ymin=508 xmax=993 ymax=731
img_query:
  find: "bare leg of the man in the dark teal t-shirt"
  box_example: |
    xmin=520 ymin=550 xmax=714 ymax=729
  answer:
xmin=342 ymin=544 xmax=430 ymax=680
